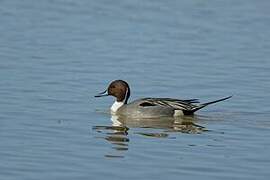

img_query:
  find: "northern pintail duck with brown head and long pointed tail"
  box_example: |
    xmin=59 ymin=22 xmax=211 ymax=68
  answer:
xmin=95 ymin=80 xmax=232 ymax=118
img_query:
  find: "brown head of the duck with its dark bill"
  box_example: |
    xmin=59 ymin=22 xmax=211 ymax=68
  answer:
xmin=95 ymin=80 xmax=130 ymax=104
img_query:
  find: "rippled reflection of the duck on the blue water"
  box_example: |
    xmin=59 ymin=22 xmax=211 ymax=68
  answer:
xmin=93 ymin=115 xmax=207 ymax=158
